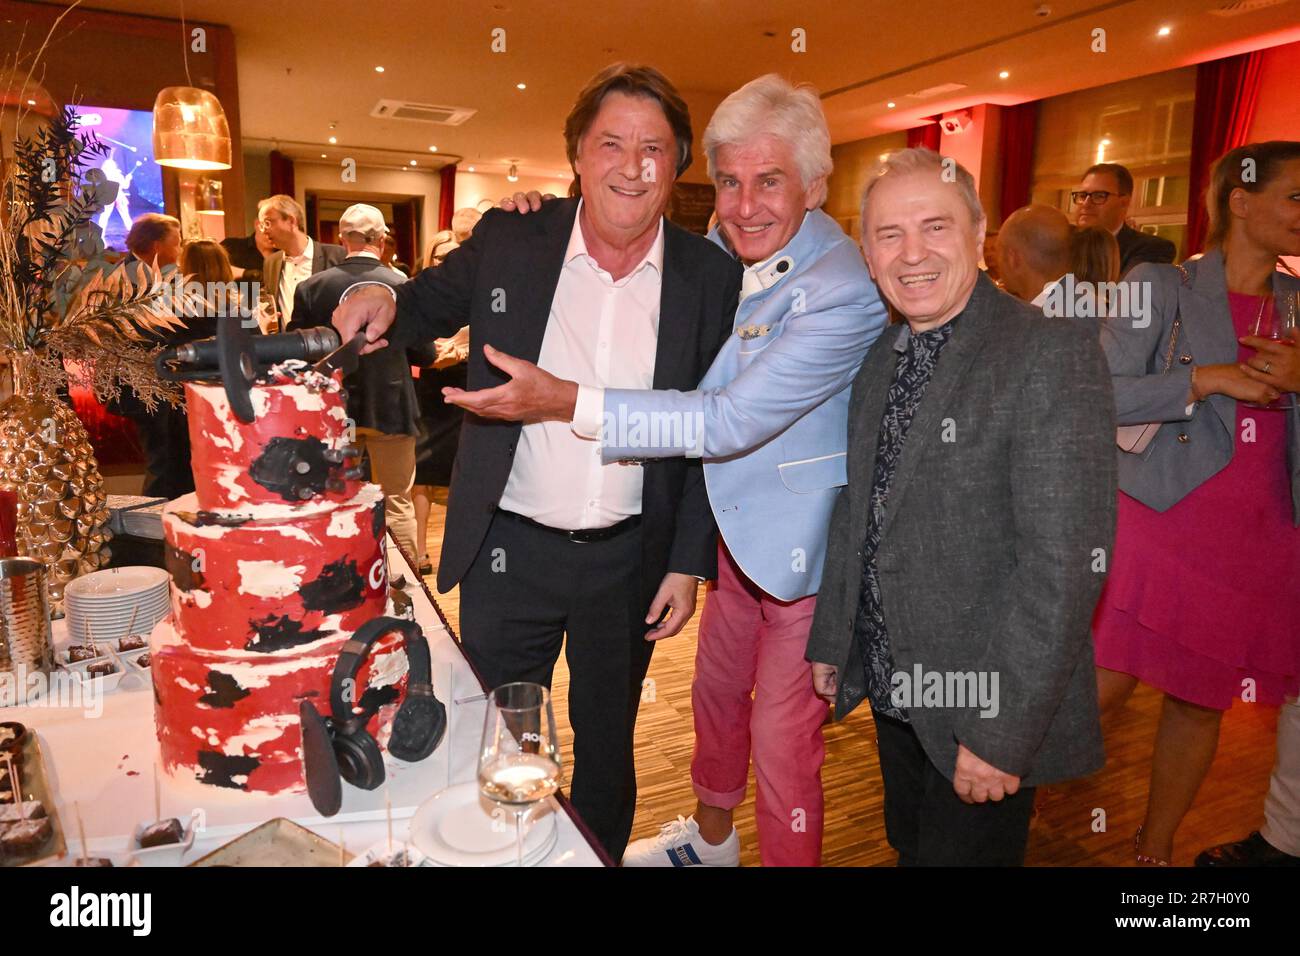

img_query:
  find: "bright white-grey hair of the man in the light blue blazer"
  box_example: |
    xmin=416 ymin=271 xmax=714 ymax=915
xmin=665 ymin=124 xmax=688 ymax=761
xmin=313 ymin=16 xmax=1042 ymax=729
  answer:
xmin=703 ymin=73 xmax=832 ymax=206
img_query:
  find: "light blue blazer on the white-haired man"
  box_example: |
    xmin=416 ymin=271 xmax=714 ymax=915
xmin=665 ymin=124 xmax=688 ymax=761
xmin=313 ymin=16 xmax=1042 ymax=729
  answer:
xmin=602 ymin=209 xmax=887 ymax=601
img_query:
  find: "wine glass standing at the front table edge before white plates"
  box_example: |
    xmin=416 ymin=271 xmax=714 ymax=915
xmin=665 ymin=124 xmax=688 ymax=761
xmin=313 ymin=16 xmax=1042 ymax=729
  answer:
xmin=478 ymin=683 xmax=560 ymax=866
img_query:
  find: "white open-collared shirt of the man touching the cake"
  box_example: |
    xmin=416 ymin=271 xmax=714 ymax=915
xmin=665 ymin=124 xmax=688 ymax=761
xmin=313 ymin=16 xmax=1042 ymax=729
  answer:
xmin=501 ymin=202 xmax=663 ymax=531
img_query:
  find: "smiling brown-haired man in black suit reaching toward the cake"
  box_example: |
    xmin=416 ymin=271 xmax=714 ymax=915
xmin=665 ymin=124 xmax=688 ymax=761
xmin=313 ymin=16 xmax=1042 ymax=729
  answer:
xmin=334 ymin=64 xmax=741 ymax=858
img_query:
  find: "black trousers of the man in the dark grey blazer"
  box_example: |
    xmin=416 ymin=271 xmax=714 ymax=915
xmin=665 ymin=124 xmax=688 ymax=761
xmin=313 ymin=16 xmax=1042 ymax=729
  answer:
xmin=871 ymin=711 xmax=1034 ymax=866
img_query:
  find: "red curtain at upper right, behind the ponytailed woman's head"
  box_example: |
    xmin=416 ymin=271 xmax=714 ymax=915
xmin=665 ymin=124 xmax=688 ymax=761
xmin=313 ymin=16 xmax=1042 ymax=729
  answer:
xmin=1183 ymin=49 xmax=1264 ymax=259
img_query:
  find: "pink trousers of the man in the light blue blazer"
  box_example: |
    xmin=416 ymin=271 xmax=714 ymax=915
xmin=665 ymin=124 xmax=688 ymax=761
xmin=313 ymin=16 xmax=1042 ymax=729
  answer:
xmin=690 ymin=544 xmax=827 ymax=866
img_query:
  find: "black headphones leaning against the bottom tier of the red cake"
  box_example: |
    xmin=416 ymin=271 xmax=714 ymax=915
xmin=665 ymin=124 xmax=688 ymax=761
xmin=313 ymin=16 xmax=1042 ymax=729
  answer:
xmin=299 ymin=618 xmax=447 ymax=817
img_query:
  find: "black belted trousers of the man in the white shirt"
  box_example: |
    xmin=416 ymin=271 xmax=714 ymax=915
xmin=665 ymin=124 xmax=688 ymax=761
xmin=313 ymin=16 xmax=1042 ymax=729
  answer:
xmin=460 ymin=511 xmax=654 ymax=860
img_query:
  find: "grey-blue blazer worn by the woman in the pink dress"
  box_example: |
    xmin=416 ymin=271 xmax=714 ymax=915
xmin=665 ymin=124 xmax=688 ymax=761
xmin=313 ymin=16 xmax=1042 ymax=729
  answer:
xmin=1101 ymin=251 xmax=1300 ymax=525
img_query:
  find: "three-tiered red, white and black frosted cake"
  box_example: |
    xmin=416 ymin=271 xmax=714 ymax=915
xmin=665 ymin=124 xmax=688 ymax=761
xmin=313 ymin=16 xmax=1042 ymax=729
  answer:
xmin=151 ymin=363 xmax=407 ymax=793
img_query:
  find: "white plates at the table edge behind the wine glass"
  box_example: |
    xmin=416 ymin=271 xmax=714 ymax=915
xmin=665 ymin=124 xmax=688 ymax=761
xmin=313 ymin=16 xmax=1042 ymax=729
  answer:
xmin=411 ymin=780 xmax=556 ymax=866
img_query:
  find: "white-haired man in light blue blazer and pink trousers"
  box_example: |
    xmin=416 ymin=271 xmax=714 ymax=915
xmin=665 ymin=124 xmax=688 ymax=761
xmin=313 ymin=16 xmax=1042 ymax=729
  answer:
xmin=446 ymin=74 xmax=887 ymax=866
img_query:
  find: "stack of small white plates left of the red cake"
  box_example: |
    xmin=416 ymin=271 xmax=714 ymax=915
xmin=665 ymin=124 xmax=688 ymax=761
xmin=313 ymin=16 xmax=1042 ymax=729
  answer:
xmin=64 ymin=567 xmax=170 ymax=644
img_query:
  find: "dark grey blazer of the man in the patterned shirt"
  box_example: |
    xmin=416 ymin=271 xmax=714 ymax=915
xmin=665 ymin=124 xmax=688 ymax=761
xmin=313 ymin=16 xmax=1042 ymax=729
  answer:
xmin=807 ymin=276 xmax=1115 ymax=786
